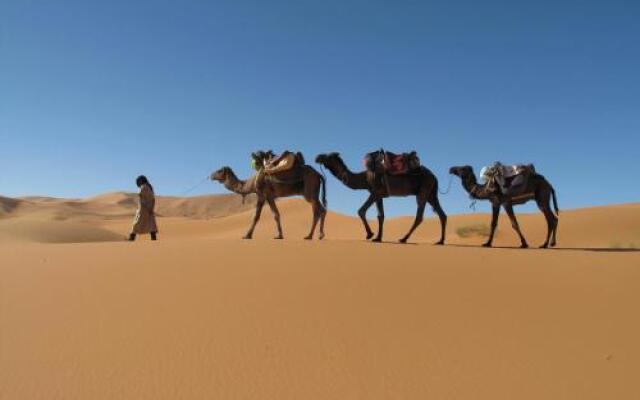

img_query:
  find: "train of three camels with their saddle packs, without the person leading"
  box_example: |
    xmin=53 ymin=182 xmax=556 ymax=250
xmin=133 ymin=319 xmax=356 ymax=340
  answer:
xmin=210 ymin=149 xmax=559 ymax=248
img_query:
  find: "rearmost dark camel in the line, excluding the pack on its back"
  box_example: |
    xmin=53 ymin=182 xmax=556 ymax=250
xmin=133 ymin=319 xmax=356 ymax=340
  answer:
xmin=449 ymin=165 xmax=560 ymax=249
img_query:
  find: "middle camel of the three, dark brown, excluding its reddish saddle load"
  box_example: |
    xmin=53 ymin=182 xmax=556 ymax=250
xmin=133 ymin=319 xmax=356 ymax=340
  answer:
xmin=316 ymin=153 xmax=447 ymax=245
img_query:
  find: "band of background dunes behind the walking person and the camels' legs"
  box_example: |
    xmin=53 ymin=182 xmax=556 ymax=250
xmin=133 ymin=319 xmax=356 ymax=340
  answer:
xmin=0 ymin=192 xmax=640 ymax=248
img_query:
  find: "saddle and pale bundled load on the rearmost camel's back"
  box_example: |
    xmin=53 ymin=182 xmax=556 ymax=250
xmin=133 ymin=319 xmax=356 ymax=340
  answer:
xmin=481 ymin=162 xmax=536 ymax=196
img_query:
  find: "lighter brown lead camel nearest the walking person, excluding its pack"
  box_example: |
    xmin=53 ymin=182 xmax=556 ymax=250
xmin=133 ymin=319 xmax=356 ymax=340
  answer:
xmin=210 ymin=153 xmax=327 ymax=240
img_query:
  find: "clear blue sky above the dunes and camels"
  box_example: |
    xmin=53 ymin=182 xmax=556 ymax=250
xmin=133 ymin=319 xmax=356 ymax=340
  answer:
xmin=0 ymin=0 xmax=640 ymax=215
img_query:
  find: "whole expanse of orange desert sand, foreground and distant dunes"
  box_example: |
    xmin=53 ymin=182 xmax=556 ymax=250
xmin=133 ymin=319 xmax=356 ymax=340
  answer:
xmin=0 ymin=193 xmax=640 ymax=400
